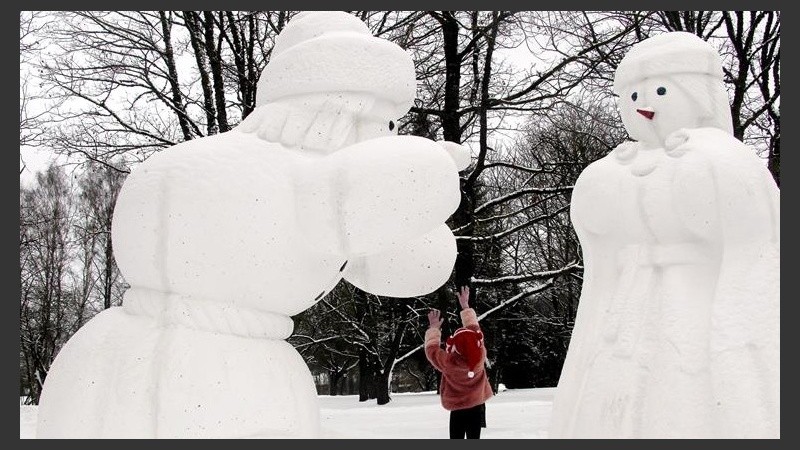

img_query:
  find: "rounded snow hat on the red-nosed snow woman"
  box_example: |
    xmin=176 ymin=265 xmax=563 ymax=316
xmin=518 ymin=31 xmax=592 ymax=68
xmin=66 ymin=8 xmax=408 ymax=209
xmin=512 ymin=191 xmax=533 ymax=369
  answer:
xmin=614 ymin=31 xmax=723 ymax=94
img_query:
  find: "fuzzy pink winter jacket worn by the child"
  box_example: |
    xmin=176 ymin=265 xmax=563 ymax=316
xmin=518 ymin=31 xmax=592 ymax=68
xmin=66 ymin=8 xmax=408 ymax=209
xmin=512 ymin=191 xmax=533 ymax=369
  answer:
xmin=425 ymin=308 xmax=494 ymax=411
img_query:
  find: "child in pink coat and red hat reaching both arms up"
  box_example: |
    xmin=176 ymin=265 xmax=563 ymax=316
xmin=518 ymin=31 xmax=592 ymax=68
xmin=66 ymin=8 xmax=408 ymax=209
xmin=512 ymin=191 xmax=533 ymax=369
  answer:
xmin=425 ymin=286 xmax=494 ymax=439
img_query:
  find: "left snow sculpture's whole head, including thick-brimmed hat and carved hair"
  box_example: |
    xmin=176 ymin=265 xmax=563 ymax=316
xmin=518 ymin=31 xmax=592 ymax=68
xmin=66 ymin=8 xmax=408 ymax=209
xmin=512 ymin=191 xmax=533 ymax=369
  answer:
xmin=243 ymin=11 xmax=416 ymax=153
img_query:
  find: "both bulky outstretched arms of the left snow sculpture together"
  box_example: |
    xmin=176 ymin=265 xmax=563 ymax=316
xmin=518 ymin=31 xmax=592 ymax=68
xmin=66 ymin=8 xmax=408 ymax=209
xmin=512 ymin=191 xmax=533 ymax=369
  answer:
xmin=296 ymin=136 xmax=460 ymax=297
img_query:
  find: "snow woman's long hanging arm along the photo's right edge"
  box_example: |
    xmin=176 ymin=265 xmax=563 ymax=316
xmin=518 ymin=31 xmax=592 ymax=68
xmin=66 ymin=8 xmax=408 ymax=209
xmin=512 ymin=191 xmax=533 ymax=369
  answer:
xmin=674 ymin=128 xmax=780 ymax=437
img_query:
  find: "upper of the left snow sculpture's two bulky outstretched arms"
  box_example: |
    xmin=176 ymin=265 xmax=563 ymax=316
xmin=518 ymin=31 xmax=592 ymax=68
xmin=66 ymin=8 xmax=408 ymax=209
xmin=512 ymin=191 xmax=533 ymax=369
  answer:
xmin=295 ymin=136 xmax=460 ymax=255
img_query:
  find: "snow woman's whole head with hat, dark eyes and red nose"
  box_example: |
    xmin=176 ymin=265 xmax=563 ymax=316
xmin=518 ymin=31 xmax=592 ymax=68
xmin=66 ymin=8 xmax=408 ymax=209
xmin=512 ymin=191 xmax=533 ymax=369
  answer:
xmin=614 ymin=32 xmax=732 ymax=147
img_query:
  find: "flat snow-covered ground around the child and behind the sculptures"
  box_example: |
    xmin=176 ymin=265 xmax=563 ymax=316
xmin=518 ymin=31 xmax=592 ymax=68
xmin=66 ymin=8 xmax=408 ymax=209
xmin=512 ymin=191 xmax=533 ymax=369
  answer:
xmin=19 ymin=388 xmax=555 ymax=439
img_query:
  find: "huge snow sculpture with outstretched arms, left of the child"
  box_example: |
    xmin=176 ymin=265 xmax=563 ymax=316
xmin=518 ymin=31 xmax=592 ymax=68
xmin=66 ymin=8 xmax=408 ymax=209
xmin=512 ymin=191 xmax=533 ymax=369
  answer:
xmin=38 ymin=12 xmax=469 ymax=438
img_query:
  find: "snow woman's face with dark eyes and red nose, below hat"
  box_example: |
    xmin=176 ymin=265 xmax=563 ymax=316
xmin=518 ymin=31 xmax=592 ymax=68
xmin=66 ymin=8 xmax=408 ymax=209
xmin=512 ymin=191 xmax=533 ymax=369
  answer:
xmin=618 ymin=77 xmax=707 ymax=147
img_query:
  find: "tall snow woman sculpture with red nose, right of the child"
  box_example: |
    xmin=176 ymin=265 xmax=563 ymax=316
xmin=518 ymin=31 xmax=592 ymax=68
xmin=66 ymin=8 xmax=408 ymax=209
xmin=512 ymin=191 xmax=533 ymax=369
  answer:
xmin=550 ymin=32 xmax=780 ymax=438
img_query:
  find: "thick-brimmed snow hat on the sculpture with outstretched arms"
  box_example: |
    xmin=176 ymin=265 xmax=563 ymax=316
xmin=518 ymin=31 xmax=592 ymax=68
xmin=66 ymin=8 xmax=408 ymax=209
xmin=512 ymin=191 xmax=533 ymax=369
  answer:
xmin=256 ymin=11 xmax=417 ymax=117
